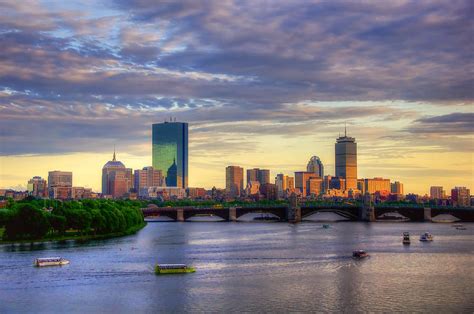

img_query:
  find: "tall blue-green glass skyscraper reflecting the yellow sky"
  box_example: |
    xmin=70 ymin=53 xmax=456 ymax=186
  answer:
xmin=152 ymin=122 xmax=188 ymax=189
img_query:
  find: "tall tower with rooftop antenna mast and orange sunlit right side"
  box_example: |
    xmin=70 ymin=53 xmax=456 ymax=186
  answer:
xmin=335 ymin=130 xmax=358 ymax=190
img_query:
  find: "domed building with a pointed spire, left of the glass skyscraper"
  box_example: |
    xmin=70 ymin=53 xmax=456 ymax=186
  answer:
xmin=102 ymin=151 xmax=133 ymax=198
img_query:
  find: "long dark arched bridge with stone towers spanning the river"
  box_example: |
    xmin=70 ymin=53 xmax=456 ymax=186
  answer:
xmin=142 ymin=204 xmax=474 ymax=222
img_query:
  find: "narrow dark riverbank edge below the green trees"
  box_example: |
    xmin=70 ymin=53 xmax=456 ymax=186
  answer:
xmin=0 ymin=221 xmax=147 ymax=244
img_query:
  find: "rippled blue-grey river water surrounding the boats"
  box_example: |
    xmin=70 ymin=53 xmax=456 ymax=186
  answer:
xmin=0 ymin=222 xmax=474 ymax=313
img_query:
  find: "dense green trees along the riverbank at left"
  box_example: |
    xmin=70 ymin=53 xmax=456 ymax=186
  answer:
xmin=0 ymin=199 xmax=144 ymax=240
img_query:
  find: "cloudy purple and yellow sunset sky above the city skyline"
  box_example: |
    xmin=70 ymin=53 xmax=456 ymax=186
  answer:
xmin=0 ymin=0 xmax=474 ymax=194
